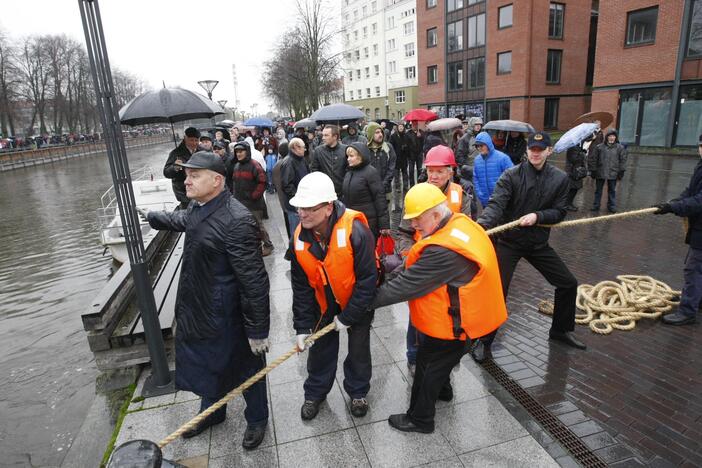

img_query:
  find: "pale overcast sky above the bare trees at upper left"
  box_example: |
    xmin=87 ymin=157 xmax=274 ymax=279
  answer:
xmin=0 ymin=0 xmax=320 ymax=113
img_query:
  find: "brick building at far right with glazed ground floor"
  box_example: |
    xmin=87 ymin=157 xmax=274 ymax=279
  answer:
xmin=592 ymin=0 xmax=702 ymax=147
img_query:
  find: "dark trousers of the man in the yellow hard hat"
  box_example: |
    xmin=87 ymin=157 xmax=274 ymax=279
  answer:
xmin=407 ymin=335 xmax=468 ymax=429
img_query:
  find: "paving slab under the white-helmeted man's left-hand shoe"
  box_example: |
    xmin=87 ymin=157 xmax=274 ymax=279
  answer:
xmin=271 ymin=381 xmax=353 ymax=444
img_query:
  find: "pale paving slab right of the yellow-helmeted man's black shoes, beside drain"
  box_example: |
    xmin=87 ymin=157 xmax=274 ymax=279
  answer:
xmin=435 ymin=396 xmax=528 ymax=453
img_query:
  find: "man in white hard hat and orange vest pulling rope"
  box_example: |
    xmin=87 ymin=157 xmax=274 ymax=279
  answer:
xmin=290 ymin=172 xmax=378 ymax=420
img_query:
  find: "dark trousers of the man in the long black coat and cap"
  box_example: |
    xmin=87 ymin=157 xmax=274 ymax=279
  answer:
xmin=200 ymin=356 xmax=268 ymax=427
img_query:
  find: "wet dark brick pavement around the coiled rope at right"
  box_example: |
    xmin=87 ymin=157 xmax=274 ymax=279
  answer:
xmin=484 ymin=155 xmax=702 ymax=466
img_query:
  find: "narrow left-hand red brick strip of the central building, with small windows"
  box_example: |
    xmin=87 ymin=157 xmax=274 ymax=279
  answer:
xmin=417 ymin=0 xmax=446 ymax=106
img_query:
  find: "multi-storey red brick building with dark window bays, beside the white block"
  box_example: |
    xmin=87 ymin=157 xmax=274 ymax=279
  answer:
xmin=417 ymin=0 xmax=596 ymax=129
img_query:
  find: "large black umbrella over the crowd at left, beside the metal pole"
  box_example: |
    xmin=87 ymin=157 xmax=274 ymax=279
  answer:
xmin=119 ymin=87 xmax=224 ymax=144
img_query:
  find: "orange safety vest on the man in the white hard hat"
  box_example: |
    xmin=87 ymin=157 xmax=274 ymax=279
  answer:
xmin=293 ymin=208 xmax=368 ymax=314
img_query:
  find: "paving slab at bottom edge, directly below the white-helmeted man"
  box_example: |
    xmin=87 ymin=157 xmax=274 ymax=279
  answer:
xmin=278 ymin=428 xmax=370 ymax=468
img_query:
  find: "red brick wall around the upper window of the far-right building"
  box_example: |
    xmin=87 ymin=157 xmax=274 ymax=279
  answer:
xmin=593 ymin=0 xmax=684 ymax=87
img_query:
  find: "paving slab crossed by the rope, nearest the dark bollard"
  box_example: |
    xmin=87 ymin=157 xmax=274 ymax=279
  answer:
xmin=115 ymin=401 xmax=211 ymax=460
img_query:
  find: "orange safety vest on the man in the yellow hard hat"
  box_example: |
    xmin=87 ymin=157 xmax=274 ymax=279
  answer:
xmin=406 ymin=213 xmax=507 ymax=340
